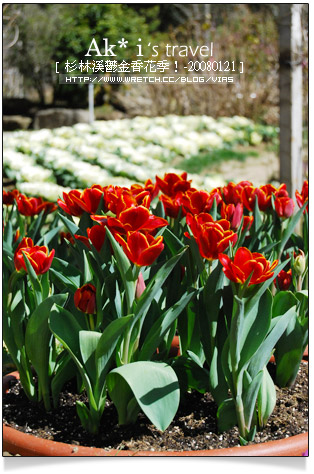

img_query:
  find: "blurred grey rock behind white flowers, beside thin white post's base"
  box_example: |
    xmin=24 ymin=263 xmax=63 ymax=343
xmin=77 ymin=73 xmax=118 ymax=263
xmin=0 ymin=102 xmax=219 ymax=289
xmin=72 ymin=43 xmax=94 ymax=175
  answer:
xmin=34 ymin=109 xmax=89 ymax=130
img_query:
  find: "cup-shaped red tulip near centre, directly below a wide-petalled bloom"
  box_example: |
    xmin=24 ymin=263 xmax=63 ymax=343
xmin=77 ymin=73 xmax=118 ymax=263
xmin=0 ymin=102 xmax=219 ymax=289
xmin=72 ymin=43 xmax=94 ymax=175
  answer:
xmin=115 ymin=232 xmax=164 ymax=267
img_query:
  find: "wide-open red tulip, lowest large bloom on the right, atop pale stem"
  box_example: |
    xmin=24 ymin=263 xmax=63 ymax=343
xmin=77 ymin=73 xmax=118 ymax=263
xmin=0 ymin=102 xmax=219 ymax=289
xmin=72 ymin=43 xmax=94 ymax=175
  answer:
xmin=219 ymin=247 xmax=278 ymax=286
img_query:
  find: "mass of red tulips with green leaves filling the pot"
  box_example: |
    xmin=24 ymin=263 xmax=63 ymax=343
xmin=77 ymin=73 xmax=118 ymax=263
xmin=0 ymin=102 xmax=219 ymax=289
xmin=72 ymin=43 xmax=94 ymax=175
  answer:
xmin=3 ymin=173 xmax=308 ymax=452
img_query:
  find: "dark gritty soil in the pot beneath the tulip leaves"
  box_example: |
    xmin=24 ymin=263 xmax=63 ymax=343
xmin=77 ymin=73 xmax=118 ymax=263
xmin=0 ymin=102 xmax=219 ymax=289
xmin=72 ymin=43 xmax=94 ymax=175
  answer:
xmin=3 ymin=362 xmax=308 ymax=451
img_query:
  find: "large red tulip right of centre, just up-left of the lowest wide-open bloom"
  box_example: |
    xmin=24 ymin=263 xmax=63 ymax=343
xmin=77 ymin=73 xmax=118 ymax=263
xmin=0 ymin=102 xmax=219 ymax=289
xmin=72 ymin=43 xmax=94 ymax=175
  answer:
xmin=186 ymin=213 xmax=238 ymax=260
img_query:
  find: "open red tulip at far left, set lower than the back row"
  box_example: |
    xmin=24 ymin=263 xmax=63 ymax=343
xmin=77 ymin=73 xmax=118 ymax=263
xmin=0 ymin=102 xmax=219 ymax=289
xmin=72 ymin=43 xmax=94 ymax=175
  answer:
xmin=14 ymin=237 xmax=55 ymax=275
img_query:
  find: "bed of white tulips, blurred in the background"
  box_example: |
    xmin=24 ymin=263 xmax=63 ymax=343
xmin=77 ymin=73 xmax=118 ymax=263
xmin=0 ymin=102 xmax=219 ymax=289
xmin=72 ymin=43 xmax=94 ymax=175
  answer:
xmin=3 ymin=115 xmax=277 ymax=201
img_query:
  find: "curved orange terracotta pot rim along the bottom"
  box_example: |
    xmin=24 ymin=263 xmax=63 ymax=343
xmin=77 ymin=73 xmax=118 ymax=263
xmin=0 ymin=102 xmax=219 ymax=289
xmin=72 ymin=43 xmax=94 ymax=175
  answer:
xmin=3 ymin=372 xmax=308 ymax=457
